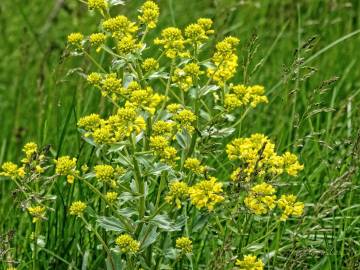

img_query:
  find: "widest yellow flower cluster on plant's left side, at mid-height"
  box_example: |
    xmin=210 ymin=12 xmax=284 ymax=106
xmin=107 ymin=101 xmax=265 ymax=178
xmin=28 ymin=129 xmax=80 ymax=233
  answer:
xmin=78 ymin=105 xmax=146 ymax=144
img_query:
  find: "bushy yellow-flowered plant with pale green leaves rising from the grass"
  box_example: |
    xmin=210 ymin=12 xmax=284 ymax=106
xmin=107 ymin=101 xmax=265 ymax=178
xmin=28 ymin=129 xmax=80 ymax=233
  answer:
xmin=1 ymin=0 xmax=304 ymax=270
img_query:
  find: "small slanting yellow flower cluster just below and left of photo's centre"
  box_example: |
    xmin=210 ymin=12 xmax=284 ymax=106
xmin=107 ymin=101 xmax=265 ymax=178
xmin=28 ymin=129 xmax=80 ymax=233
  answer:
xmin=150 ymin=136 xmax=179 ymax=165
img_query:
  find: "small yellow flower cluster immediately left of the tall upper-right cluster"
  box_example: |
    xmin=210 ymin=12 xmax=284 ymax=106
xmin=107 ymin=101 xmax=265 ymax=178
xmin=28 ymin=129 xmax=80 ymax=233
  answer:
xmin=171 ymin=63 xmax=204 ymax=92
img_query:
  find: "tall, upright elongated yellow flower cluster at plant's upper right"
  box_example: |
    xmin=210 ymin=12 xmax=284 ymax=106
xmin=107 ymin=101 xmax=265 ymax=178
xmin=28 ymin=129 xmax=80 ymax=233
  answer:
xmin=207 ymin=36 xmax=240 ymax=86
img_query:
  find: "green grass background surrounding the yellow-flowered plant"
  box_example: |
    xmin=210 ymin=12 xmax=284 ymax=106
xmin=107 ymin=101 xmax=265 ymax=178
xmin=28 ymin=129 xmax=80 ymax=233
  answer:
xmin=0 ymin=0 xmax=360 ymax=269
